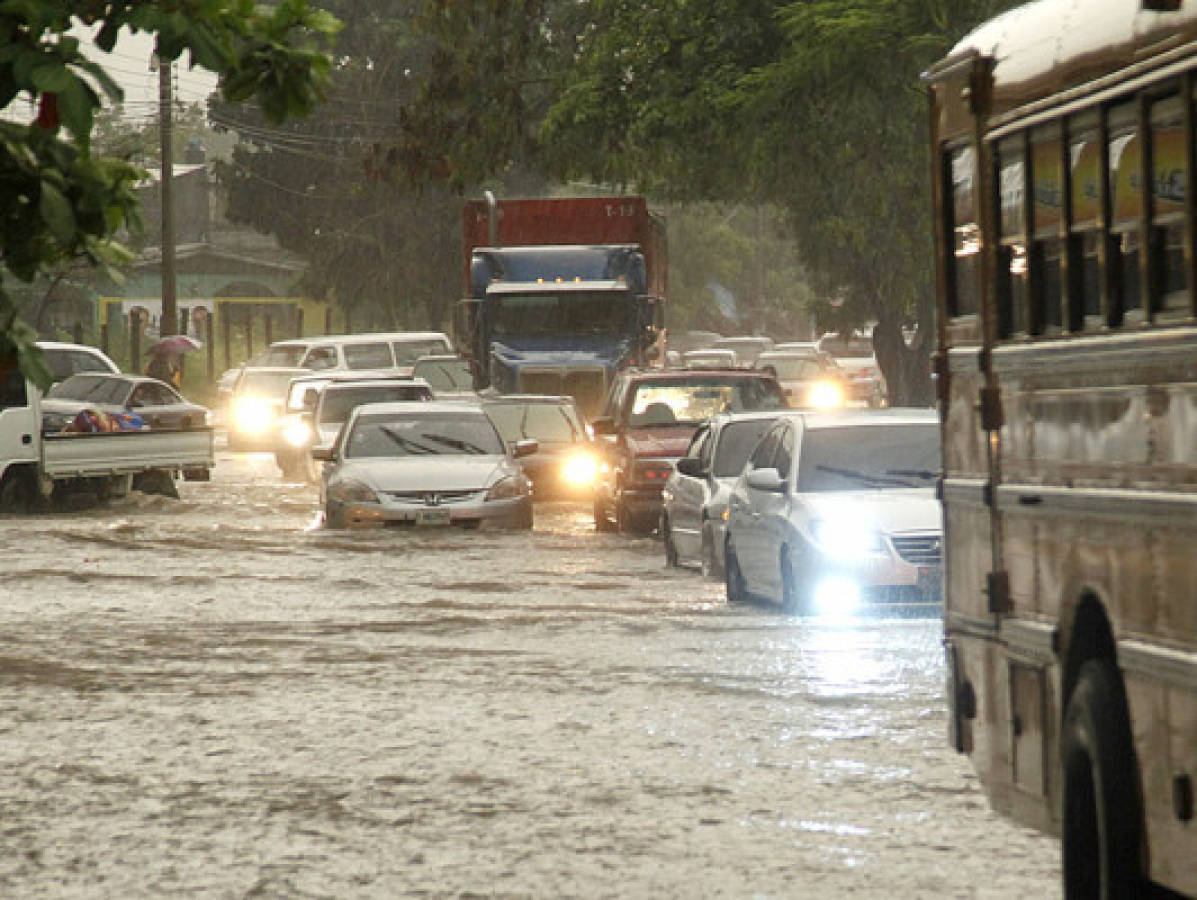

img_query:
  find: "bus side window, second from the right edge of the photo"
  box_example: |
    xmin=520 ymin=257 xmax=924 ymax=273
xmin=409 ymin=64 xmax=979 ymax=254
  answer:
xmin=1106 ymin=103 xmax=1143 ymax=327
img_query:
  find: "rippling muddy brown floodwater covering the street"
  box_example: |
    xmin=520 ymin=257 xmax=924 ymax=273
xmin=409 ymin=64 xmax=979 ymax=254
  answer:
xmin=0 ymin=455 xmax=1059 ymax=899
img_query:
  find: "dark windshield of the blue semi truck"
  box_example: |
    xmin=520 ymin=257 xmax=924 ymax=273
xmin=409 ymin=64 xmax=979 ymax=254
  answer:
xmin=491 ymin=291 xmax=628 ymax=338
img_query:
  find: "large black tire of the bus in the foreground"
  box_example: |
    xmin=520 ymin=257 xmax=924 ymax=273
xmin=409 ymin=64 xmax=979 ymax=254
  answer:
xmin=1061 ymin=659 xmax=1144 ymax=900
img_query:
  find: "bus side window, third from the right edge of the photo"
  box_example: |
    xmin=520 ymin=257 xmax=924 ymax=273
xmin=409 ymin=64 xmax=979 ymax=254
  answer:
xmin=1068 ymin=115 xmax=1105 ymax=332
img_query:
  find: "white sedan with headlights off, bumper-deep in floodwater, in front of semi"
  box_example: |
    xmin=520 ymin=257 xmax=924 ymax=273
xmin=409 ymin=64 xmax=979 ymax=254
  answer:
xmin=312 ymin=402 xmax=536 ymax=529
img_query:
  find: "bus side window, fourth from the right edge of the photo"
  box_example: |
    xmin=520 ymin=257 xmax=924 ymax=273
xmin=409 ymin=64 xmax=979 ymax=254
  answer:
xmin=1029 ymin=124 xmax=1063 ymax=334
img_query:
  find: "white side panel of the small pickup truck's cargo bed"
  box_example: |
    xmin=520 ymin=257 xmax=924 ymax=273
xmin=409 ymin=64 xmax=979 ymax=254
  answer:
xmin=42 ymin=428 xmax=214 ymax=479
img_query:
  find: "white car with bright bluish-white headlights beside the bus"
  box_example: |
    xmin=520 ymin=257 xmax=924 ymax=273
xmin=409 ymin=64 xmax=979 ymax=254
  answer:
xmin=724 ymin=409 xmax=943 ymax=615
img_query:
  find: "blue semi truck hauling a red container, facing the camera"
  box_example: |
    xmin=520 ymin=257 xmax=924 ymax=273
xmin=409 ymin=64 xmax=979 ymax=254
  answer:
xmin=454 ymin=195 xmax=667 ymax=415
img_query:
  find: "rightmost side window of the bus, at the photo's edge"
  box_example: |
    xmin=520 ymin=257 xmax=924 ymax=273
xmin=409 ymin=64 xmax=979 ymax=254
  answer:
xmin=1152 ymin=98 xmax=1189 ymax=316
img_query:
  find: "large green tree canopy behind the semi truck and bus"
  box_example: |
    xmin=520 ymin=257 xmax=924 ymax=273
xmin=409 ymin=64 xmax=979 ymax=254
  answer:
xmin=390 ymin=0 xmax=1013 ymax=402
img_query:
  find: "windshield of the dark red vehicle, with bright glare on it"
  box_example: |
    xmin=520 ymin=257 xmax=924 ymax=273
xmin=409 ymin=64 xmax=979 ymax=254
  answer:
xmin=628 ymin=377 xmax=785 ymax=428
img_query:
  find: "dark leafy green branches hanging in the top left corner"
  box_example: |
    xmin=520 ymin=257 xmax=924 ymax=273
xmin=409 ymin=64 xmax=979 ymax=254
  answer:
xmin=0 ymin=0 xmax=338 ymax=384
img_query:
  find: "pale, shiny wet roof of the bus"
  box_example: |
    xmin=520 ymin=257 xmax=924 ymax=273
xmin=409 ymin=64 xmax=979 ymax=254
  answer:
xmin=928 ymin=0 xmax=1197 ymax=114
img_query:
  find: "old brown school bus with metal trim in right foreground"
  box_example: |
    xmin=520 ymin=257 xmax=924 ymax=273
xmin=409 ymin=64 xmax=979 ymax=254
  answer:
xmin=924 ymin=0 xmax=1197 ymax=898
